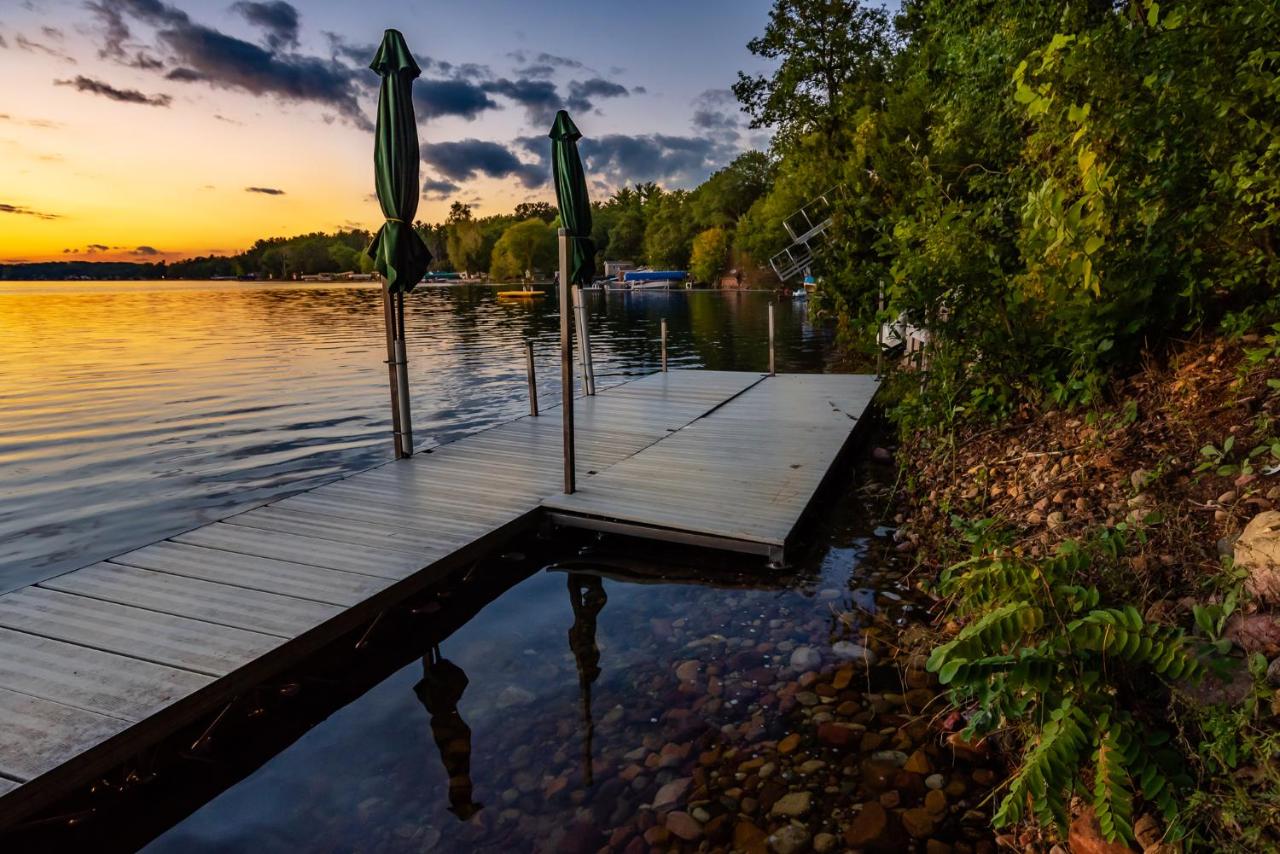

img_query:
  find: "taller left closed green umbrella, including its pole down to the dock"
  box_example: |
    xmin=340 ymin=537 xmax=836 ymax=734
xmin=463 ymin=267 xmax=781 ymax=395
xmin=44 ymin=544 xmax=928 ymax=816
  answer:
xmin=367 ymin=29 xmax=431 ymax=457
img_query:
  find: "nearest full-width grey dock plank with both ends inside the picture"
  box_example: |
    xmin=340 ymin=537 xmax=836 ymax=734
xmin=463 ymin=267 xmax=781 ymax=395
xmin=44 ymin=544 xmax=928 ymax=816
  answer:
xmin=40 ymin=563 xmax=342 ymax=638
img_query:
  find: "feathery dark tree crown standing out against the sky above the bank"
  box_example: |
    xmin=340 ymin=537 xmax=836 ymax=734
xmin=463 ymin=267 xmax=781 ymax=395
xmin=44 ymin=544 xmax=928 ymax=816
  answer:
xmin=733 ymin=0 xmax=893 ymax=140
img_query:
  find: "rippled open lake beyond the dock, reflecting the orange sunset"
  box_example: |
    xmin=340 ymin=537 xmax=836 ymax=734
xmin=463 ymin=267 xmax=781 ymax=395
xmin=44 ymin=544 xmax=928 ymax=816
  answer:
xmin=0 ymin=282 xmax=828 ymax=592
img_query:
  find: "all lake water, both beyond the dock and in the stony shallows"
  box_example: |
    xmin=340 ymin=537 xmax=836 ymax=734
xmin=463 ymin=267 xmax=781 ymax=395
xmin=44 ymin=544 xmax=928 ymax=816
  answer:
xmin=0 ymin=283 xmax=996 ymax=854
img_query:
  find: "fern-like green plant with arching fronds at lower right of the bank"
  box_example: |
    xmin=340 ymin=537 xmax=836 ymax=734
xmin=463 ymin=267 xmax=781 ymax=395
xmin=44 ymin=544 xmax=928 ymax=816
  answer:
xmin=928 ymin=537 xmax=1203 ymax=841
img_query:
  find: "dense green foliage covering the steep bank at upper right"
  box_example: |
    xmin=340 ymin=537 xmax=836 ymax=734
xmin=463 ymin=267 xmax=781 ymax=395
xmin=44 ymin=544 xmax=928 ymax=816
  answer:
xmin=737 ymin=0 xmax=1280 ymax=429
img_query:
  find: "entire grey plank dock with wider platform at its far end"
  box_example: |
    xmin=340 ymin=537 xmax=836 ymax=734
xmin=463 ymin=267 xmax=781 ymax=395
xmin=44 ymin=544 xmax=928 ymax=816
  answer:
xmin=0 ymin=371 xmax=876 ymax=828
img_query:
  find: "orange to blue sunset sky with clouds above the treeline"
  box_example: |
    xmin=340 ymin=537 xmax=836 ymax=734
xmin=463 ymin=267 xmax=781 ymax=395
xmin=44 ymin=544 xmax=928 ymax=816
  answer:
xmin=0 ymin=0 xmax=771 ymax=262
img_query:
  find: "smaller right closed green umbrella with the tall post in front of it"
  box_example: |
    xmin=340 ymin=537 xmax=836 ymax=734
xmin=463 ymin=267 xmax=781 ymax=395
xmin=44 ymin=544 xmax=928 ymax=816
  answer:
xmin=548 ymin=110 xmax=595 ymax=493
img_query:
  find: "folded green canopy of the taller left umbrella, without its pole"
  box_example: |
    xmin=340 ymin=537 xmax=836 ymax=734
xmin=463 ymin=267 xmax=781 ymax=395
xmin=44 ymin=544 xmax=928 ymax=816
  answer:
xmin=367 ymin=29 xmax=431 ymax=293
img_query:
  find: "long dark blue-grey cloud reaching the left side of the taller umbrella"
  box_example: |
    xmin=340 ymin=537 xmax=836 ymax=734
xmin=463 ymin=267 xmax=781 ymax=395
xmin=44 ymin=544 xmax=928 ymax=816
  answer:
xmin=88 ymin=0 xmax=372 ymax=128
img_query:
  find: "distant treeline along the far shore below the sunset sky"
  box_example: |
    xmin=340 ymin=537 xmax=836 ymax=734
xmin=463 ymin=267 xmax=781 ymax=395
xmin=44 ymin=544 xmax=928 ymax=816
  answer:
xmin=0 ymin=151 xmax=777 ymax=282
